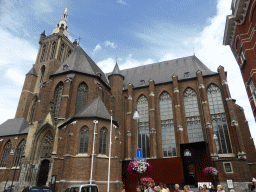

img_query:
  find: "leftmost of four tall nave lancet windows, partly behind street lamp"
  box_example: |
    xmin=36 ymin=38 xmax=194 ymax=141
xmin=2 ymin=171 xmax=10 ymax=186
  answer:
xmin=137 ymin=95 xmax=150 ymax=158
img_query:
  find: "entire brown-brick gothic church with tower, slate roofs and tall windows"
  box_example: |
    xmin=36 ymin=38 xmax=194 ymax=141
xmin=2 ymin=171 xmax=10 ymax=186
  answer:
xmin=0 ymin=7 xmax=256 ymax=192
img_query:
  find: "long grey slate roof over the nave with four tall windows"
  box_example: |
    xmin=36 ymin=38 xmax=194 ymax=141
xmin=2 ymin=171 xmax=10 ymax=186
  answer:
xmin=106 ymin=55 xmax=218 ymax=89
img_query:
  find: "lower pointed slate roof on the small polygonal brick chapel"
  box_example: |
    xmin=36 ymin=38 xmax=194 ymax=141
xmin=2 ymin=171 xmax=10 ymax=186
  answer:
xmin=59 ymin=97 xmax=117 ymax=128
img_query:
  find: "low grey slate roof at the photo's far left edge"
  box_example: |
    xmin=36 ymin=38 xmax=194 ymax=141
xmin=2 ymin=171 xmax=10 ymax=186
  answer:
xmin=0 ymin=118 xmax=29 ymax=137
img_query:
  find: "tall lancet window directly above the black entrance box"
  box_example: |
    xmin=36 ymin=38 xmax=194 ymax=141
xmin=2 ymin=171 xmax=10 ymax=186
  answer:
xmin=184 ymin=88 xmax=203 ymax=143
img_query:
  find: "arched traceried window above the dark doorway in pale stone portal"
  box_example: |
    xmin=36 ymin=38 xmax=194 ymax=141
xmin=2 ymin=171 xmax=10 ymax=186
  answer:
xmin=39 ymin=131 xmax=53 ymax=157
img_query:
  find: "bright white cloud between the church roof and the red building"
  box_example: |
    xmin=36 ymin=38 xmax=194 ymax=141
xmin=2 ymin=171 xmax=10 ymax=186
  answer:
xmin=194 ymin=0 xmax=256 ymax=141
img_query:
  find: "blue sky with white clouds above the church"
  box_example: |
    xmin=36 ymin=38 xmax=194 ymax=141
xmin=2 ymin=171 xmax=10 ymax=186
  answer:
xmin=0 ymin=0 xmax=256 ymax=141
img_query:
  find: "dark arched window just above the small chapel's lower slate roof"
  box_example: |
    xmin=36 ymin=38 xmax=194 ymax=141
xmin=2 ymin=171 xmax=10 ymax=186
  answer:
xmin=75 ymin=82 xmax=87 ymax=113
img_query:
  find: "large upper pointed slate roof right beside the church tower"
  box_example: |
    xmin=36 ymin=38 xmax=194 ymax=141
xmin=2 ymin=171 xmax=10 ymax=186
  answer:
xmin=51 ymin=46 xmax=108 ymax=85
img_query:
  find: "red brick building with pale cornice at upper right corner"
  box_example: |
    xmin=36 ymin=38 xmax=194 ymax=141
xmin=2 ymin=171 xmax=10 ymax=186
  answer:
xmin=223 ymin=0 xmax=256 ymax=121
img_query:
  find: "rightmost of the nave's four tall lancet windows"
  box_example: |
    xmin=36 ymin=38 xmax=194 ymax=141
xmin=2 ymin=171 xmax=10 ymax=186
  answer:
xmin=207 ymin=84 xmax=232 ymax=154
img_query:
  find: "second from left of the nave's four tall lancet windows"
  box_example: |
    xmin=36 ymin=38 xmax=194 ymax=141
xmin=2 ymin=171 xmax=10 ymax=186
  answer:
xmin=160 ymin=92 xmax=176 ymax=157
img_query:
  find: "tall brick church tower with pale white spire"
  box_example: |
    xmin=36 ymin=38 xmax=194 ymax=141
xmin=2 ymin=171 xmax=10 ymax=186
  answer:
xmin=15 ymin=8 xmax=77 ymax=123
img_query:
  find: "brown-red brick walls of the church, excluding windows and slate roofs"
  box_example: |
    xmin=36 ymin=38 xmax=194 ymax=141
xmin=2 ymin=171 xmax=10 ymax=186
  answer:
xmin=0 ymin=7 xmax=256 ymax=192
